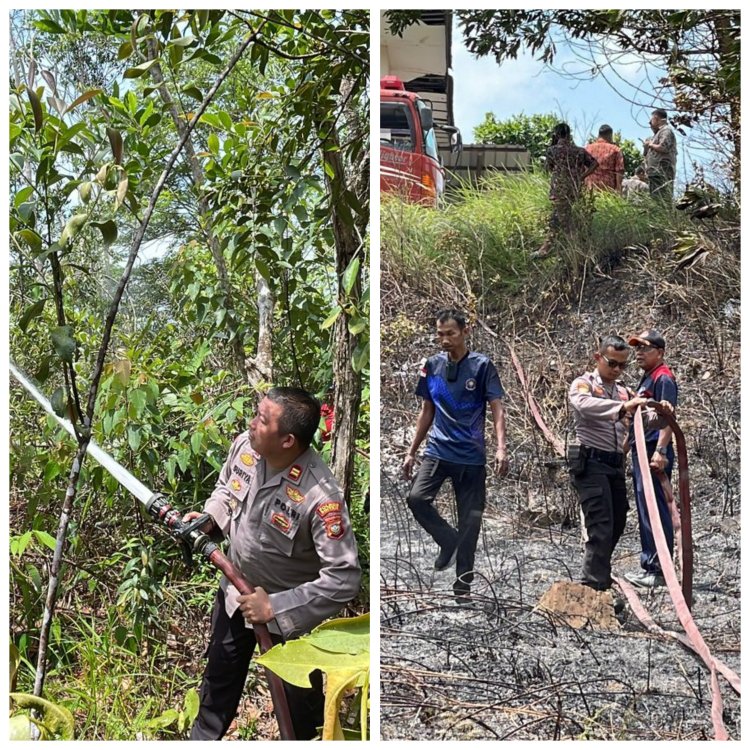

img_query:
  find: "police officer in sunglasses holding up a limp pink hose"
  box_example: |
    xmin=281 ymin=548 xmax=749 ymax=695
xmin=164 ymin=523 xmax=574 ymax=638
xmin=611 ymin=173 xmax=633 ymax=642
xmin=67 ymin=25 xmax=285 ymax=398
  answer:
xmin=568 ymin=336 xmax=672 ymax=591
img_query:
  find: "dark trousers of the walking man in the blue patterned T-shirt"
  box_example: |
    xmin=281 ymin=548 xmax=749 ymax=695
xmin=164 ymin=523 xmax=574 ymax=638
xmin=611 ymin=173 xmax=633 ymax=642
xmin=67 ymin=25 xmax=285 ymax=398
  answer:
xmin=408 ymin=457 xmax=487 ymax=583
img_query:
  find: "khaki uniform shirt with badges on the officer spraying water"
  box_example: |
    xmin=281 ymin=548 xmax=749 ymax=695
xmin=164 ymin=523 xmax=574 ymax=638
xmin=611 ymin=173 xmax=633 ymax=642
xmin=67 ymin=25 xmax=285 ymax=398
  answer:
xmin=204 ymin=432 xmax=361 ymax=638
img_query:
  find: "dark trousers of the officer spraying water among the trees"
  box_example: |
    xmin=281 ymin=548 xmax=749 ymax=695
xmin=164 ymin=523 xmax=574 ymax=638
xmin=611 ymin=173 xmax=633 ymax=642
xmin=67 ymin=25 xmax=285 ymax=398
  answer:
xmin=190 ymin=589 xmax=324 ymax=740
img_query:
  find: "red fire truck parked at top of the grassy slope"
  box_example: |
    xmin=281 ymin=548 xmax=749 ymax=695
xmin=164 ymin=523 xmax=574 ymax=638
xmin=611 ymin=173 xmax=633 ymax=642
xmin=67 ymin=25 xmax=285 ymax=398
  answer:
xmin=380 ymin=76 xmax=461 ymax=206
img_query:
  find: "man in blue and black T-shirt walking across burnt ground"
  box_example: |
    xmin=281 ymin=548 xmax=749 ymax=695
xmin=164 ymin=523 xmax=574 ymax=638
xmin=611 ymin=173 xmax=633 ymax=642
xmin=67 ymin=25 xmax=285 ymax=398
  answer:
xmin=403 ymin=310 xmax=508 ymax=601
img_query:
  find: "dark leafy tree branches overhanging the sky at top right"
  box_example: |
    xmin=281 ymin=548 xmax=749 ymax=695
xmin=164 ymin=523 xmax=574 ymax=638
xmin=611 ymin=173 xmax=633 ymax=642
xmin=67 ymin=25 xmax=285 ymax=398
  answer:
xmin=387 ymin=9 xmax=740 ymax=189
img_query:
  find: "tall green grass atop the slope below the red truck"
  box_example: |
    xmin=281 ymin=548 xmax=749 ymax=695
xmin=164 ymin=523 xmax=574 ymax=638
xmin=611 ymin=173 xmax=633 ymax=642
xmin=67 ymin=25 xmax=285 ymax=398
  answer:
xmin=380 ymin=172 xmax=687 ymax=293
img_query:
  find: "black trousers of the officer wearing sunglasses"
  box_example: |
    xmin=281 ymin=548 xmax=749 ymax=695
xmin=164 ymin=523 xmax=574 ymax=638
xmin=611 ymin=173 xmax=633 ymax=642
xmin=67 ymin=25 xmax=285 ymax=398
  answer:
xmin=571 ymin=458 xmax=628 ymax=589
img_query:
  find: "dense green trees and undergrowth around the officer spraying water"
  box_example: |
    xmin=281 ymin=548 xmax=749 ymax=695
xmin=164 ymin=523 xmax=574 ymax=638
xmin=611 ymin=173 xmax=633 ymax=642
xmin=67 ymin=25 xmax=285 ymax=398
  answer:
xmin=10 ymin=10 xmax=369 ymax=740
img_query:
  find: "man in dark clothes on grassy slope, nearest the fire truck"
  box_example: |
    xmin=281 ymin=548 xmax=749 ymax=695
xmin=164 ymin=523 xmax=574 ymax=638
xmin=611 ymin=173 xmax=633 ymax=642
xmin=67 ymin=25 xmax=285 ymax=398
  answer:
xmin=533 ymin=122 xmax=597 ymax=258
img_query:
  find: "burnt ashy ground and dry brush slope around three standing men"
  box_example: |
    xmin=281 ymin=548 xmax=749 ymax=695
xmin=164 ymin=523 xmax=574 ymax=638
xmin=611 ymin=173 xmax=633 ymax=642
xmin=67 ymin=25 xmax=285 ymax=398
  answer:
xmin=381 ymin=248 xmax=740 ymax=740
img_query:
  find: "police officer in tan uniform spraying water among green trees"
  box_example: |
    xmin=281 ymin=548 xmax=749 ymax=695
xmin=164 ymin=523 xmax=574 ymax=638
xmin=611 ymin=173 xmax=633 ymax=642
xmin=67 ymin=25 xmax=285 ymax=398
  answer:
xmin=185 ymin=388 xmax=360 ymax=740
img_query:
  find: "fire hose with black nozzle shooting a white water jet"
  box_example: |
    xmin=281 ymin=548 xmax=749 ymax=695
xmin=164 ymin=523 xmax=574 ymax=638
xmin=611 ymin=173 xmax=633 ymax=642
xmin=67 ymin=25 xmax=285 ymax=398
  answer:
xmin=10 ymin=362 xmax=295 ymax=740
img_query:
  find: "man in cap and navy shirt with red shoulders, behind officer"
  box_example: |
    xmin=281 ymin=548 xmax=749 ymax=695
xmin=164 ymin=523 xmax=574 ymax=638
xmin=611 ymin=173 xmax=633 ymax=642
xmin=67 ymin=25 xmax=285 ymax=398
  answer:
xmin=625 ymin=329 xmax=677 ymax=588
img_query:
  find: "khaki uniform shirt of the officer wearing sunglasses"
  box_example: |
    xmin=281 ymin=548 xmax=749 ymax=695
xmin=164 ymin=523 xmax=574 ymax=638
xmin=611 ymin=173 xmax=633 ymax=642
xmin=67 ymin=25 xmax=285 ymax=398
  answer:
xmin=568 ymin=370 xmax=666 ymax=453
